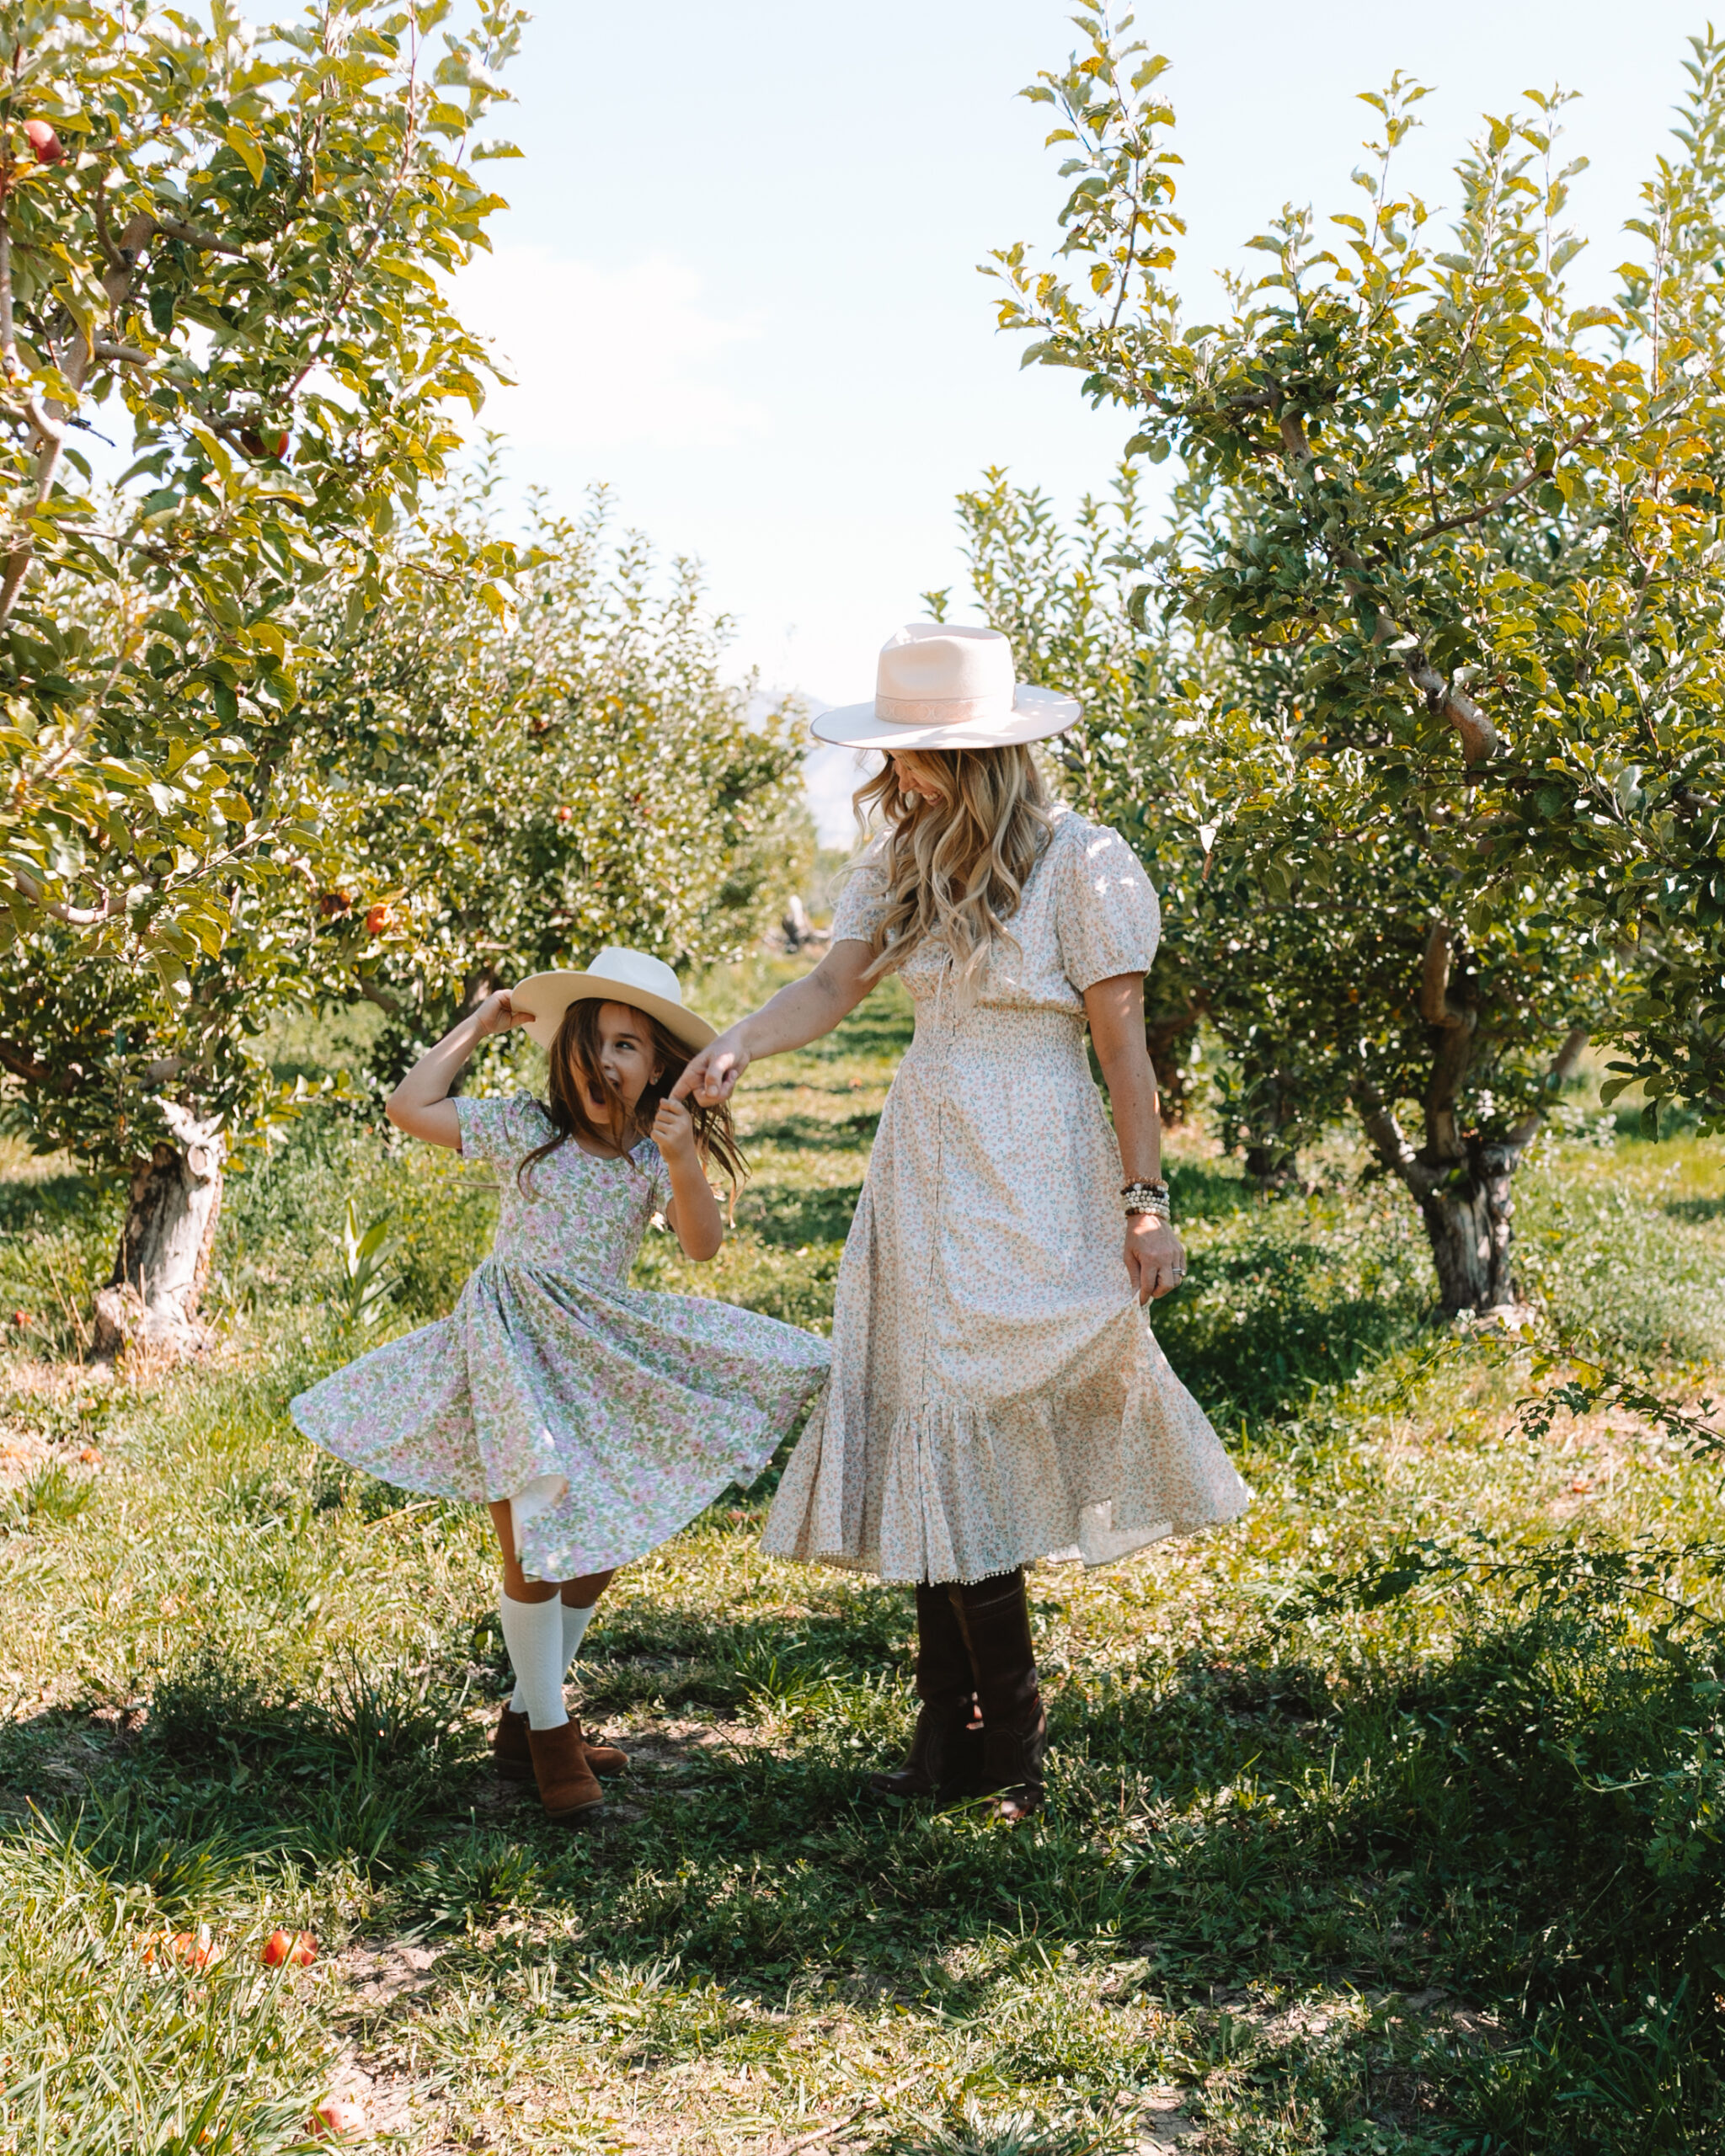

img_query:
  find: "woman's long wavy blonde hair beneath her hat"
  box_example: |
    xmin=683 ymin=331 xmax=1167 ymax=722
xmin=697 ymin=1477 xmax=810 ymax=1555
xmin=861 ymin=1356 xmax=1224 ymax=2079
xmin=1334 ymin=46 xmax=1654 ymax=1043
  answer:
xmin=852 ymin=744 xmax=1055 ymax=994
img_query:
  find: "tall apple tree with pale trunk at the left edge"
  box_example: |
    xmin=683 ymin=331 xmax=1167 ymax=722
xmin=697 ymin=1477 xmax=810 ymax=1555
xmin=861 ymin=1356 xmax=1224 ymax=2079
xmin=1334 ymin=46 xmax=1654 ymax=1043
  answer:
xmin=0 ymin=0 xmax=524 ymax=1345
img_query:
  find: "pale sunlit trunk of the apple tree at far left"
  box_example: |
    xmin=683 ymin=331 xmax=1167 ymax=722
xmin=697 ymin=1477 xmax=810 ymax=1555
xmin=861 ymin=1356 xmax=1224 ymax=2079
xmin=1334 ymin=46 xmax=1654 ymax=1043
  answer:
xmin=91 ymin=1104 xmax=224 ymax=1363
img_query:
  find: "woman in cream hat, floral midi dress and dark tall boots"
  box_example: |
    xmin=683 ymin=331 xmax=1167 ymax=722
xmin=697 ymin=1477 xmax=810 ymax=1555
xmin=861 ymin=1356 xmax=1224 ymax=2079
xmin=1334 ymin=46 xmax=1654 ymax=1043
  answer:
xmin=677 ymin=623 xmax=1247 ymax=1820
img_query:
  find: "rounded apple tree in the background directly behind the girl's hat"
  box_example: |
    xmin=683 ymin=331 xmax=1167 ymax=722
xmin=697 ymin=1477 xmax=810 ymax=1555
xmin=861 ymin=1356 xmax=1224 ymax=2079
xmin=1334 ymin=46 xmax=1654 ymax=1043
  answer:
xmin=289 ymin=478 xmax=813 ymax=1075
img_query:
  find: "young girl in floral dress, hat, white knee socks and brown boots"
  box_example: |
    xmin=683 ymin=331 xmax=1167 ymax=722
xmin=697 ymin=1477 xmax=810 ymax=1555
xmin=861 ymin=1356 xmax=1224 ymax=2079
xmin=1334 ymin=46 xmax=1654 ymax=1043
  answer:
xmin=293 ymin=951 xmax=828 ymax=1820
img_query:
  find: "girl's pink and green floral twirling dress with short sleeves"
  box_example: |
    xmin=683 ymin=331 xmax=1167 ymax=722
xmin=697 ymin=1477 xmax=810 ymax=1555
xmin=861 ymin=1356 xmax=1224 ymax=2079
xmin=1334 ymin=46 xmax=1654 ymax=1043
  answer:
xmin=293 ymin=1097 xmax=830 ymax=1580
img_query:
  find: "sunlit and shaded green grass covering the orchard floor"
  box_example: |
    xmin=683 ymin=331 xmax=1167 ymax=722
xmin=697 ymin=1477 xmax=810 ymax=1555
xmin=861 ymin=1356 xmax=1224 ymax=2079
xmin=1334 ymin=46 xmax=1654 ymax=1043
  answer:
xmin=0 ymin=968 xmax=1725 ymax=2156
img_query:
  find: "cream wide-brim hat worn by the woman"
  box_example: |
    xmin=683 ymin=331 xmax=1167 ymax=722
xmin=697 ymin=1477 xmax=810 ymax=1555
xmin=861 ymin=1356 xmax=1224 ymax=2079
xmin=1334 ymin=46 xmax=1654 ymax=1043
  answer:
xmin=813 ymin=621 xmax=1082 ymax=748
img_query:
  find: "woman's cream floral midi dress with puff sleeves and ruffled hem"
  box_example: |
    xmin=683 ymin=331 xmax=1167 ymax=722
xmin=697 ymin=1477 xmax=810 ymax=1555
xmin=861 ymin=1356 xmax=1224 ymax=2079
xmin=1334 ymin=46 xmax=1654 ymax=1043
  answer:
xmin=761 ymin=811 xmax=1248 ymax=1580
